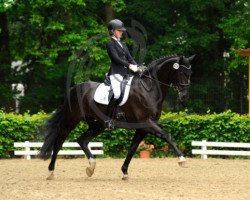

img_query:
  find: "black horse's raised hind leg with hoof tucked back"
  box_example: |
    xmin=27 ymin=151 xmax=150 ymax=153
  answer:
xmin=77 ymin=121 xmax=103 ymax=177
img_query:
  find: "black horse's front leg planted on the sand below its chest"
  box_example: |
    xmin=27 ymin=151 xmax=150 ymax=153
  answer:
xmin=122 ymin=129 xmax=146 ymax=180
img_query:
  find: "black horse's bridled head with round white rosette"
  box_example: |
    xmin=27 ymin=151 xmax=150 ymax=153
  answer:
xmin=171 ymin=55 xmax=195 ymax=101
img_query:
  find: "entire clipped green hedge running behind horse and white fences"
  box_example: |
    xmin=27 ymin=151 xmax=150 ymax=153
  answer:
xmin=0 ymin=111 xmax=250 ymax=158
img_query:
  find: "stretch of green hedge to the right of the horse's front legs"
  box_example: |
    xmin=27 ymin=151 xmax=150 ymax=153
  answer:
xmin=150 ymin=111 xmax=250 ymax=156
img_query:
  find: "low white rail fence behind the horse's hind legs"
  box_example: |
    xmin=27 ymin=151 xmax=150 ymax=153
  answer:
xmin=14 ymin=141 xmax=104 ymax=160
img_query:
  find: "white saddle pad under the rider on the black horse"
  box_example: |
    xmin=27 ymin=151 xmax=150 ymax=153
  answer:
xmin=94 ymin=76 xmax=134 ymax=106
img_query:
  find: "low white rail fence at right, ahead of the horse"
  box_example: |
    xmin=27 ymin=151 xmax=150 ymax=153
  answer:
xmin=192 ymin=140 xmax=250 ymax=159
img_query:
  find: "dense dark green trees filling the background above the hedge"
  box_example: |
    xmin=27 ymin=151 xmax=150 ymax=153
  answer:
xmin=0 ymin=0 xmax=250 ymax=113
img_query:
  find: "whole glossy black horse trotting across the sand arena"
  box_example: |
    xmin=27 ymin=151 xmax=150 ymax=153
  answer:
xmin=39 ymin=56 xmax=194 ymax=179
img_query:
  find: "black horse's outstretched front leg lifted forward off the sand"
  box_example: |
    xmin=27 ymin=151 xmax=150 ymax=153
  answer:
xmin=145 ymin=121 xmax=186 ymax=167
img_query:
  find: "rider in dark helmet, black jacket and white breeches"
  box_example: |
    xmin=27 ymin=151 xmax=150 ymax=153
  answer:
xmin=105 ymin=19 xmax=138 ymax=128
